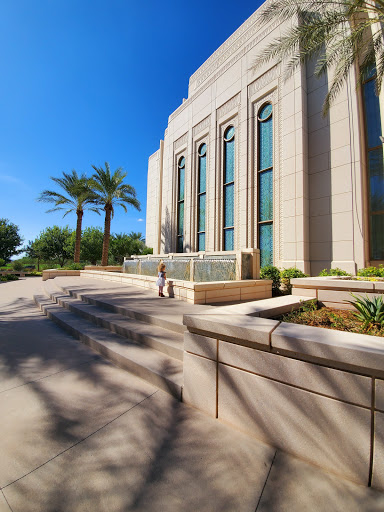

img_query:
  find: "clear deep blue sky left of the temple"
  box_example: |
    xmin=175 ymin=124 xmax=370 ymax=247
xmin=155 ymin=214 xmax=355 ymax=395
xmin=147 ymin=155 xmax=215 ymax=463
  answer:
xmin=0 ymin=0 xmax=261 ymax=248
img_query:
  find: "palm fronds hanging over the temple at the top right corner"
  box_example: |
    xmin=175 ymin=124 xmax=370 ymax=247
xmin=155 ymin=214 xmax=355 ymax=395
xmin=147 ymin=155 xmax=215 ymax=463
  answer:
xmin=253 ymin=0 xmax=384 ymax=115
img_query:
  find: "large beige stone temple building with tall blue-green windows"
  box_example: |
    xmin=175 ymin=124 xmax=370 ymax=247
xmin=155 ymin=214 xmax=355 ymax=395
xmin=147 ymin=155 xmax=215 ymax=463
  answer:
xmin=146 ymin=3 xmax=384 ymax=275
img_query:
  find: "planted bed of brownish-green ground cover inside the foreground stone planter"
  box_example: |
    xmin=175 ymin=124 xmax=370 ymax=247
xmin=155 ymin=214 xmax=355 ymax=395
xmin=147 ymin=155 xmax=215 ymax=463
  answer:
xmin=275 ymin=301 xmax=384 ymax=337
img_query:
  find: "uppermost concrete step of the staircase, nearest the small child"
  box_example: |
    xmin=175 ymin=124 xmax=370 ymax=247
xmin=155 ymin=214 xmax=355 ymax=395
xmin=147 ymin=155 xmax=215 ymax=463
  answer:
xmin=52 ymin=279 xmax=186 ymax=334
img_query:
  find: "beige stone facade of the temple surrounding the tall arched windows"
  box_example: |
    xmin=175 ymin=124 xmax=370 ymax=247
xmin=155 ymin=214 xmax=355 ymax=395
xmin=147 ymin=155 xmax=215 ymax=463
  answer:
xmin=147 ymin=3 xmax=364 ymax=275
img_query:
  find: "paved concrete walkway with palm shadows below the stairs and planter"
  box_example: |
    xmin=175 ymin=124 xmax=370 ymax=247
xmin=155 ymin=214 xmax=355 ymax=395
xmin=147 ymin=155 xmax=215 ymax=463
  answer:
xmin=0 ymin=278 xmax=384 ymax=512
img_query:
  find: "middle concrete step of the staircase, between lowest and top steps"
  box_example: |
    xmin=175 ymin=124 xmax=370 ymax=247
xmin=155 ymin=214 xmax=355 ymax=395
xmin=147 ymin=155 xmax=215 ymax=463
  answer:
xmin=45 ymin=292 xmax=184 ymax=361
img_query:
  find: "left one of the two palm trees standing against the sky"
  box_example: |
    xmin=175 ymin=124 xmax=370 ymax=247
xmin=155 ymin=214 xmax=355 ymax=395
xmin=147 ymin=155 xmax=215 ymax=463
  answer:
xmin=37 ymin=170 xmax=100 ymax=263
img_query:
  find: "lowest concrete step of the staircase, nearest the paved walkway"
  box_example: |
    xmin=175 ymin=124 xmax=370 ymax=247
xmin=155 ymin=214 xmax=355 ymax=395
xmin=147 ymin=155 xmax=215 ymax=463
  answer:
xmin=34 ymin=295 xmax=183 ymax=400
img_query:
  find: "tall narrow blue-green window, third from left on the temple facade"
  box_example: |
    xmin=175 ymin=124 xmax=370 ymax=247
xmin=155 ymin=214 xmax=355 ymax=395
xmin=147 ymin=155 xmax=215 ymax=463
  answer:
xmin=223 ymin=126 xmax=235 ymax=251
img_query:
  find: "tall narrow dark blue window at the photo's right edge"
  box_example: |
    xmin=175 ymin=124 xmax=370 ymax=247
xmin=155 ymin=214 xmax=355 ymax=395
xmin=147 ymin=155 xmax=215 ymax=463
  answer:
xmin=363 ymin=71 xmax=384 ymax=260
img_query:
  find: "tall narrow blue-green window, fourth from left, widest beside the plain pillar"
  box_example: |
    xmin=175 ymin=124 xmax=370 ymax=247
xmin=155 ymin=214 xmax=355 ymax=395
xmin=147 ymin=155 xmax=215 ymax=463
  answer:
xmin=257 ymin=103 xmax=273 ymax=267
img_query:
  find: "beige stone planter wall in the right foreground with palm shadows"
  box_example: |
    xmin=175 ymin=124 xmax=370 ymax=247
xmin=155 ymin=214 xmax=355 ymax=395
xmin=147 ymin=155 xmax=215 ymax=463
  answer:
xmin=183 ymin=296 xmax=384 ymax=489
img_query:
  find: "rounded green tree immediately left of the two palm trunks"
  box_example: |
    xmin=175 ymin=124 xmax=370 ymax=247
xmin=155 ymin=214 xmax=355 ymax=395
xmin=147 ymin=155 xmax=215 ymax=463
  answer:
xmin=35 ymin=226 xmax=73 ymax=266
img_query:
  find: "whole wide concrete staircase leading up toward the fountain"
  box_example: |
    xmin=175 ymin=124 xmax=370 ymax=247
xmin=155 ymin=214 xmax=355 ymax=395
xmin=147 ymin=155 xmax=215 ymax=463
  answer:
xmin=34 ymin=278 xmax=196 ymax=400
